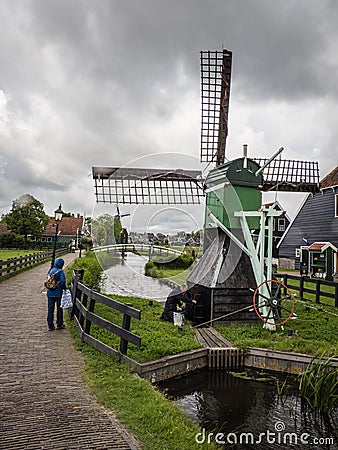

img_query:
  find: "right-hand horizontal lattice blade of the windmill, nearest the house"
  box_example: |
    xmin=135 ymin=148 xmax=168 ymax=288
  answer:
xmin=253 ymin=158 xmax=319 ymax=192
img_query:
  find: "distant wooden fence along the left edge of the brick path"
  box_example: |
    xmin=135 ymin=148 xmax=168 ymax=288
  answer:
xmin=0 ymin=248 xmax=68 ymax=281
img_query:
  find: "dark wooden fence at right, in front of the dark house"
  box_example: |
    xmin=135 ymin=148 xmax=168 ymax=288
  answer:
xmin=276 ymin=274 xmax=338 ymax=308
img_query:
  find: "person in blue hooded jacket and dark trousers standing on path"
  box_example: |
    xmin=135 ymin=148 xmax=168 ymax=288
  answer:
xmin=47 ymin=258 xmax=66 ymax=331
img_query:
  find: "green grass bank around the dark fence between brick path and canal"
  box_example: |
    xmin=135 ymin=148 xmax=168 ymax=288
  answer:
xmin=67 ymin=254 xmax=217 ymax=450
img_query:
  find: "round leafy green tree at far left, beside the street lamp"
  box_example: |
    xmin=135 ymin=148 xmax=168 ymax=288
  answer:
xmin=4 ymin=194 xmax=49 ymax=245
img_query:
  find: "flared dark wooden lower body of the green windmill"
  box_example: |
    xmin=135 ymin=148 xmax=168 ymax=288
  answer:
xmin=187 ymin=229 xmax=258 ymax=323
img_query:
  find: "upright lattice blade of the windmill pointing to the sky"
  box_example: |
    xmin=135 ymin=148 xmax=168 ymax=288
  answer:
xmin=201 ymin=50 xmax=232 ymax=166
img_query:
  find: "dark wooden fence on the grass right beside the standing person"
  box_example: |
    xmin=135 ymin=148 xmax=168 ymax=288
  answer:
xmin=70 ymin=269 xmax=141 ymax=363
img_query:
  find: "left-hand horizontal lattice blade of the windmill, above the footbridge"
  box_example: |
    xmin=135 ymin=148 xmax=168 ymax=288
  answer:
xmin=92 ymin=167 xmax=204 ymax=205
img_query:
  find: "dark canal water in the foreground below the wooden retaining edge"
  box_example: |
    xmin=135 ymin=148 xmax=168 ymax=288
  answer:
xmin=159 ymin=370 xmax=338 ymax=450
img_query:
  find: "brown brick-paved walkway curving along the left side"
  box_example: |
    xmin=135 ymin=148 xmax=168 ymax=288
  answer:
xmin=0 ymin=254 xmax=140 ymax=450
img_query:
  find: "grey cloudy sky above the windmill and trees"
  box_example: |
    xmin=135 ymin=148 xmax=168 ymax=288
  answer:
xmin=0 ymin=0 xmax=338 ymax=229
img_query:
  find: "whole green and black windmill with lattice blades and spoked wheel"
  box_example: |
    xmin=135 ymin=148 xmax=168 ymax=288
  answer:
xmin=92 ymin=49 xmax=319 ymax=329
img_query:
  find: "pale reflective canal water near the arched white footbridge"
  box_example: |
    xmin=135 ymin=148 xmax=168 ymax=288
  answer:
xmin=97 ymin=252 xmax=171 ymax=303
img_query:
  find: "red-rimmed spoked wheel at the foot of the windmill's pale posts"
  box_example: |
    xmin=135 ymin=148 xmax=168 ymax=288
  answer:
xmin=253 ymin=280 xmax=295 ymax=326
